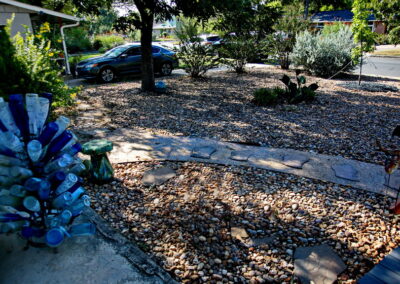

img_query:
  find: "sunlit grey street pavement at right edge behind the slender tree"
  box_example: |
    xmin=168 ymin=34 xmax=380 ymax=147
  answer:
xmin=354 ymin=56 xmax=400 ymax=79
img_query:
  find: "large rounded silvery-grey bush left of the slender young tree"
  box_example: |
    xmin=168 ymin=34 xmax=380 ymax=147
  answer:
xmin=291 ymin=26 xmax=354 ymax=77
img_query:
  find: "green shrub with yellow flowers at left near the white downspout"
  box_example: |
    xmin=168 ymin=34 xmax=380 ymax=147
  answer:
xmin=7 ymin=23 xmax=79 ymax=107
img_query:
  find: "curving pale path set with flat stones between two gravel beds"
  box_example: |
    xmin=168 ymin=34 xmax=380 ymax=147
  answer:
xmin=77 ymin=129 xmax=400 ymax=197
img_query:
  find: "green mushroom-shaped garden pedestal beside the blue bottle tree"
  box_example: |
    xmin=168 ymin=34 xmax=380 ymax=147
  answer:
xmin=82 ymin=139 xmax=114 ymax=183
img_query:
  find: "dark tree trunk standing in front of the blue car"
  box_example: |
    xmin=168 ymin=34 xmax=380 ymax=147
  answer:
xmin=140 ymin=15 xmax=155 ymax=91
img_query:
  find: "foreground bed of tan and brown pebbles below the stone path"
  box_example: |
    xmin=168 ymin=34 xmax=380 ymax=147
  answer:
xmin=88 ymin=162 xmax=400 ymax=283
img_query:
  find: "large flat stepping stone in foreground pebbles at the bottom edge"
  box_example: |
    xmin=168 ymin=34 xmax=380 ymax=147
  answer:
xmin=294 ymin=244 xmax=346 ymax=284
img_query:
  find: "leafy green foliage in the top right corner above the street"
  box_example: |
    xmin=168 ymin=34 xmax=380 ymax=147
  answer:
xmin=371 ymin=0 xmax=400 ymax=44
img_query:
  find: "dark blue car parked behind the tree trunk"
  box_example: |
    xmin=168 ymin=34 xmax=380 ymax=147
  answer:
xmin=75 ymin=44 xmax=178 ymax=83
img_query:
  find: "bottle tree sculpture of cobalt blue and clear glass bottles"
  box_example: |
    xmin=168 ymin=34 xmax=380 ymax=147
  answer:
xmin=0 ymin=93 xmax=95 ymax=247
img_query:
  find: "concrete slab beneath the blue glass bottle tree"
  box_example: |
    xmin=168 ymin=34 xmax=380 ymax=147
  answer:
xmin=0 ymin=209 xmax=176 ymax=284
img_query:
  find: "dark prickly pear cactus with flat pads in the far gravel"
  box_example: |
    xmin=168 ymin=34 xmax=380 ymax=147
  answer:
xmin=280 ymin=71 xmax=318 ymax=104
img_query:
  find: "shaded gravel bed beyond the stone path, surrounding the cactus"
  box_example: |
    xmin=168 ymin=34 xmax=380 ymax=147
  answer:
xmin=78 ymin=67 xmax=400 ymax=163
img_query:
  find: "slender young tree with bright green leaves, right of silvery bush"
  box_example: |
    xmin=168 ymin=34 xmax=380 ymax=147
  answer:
xmin=351 ymin=0 xmax=375 ymax=84
